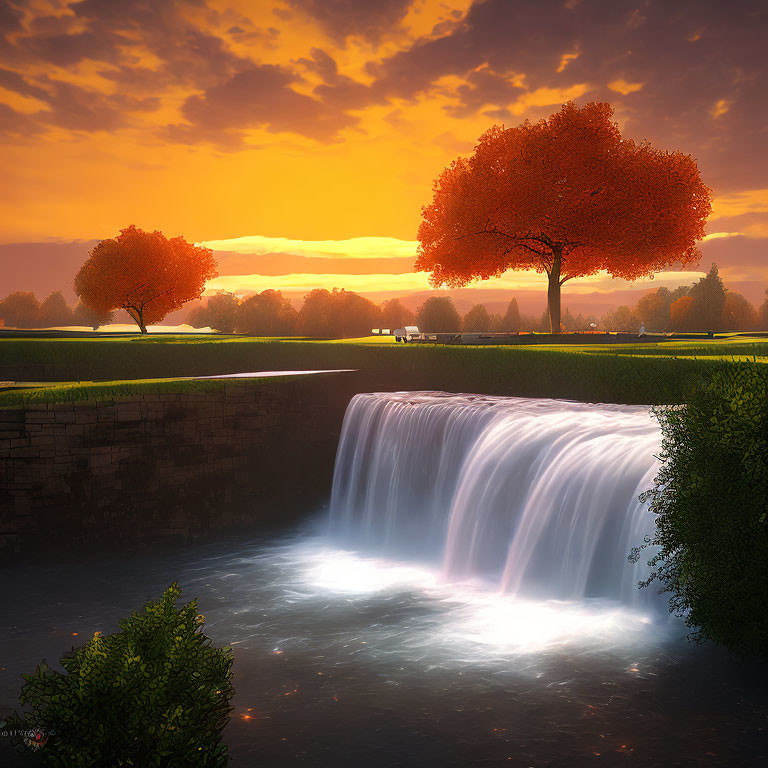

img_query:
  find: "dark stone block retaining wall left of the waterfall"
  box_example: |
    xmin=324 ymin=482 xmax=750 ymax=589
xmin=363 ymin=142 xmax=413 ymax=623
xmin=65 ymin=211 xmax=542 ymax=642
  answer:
xmin=0 ymin=372 xmax=376 ymax=553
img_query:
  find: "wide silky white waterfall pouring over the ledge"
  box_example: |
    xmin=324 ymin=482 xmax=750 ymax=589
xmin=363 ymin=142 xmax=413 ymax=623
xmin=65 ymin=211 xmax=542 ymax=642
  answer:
xmin=330 ymin=392 xmax=660 ymax=606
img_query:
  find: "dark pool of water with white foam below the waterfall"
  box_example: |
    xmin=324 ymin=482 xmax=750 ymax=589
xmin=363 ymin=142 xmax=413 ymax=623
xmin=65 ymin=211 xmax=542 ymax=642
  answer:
xmin=0 ymin=531 xmax=768 ymax=768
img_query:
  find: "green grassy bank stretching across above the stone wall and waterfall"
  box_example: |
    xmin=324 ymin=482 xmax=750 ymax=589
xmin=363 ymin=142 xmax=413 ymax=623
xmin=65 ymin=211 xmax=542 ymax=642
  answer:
xmin=0 ymin=336 xmax=768 ymax=404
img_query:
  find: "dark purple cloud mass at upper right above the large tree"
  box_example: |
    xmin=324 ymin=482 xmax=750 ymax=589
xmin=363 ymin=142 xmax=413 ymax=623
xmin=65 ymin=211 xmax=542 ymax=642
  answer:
xmin=368 ymin=0 xmax=768 ymax=189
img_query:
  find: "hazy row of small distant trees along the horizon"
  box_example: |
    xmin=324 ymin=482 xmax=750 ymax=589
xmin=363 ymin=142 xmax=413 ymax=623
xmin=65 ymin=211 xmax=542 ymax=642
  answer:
xmin=0 ymin=264 xmax=768 ymax=338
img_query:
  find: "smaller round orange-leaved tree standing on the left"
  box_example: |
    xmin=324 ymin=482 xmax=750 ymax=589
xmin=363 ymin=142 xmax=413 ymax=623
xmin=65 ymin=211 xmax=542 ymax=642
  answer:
xmin=75 ymin=225 xmax=218 ymax=333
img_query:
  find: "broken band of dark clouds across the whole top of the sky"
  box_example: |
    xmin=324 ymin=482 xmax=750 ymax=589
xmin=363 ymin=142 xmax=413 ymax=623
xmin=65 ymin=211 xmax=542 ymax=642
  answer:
xmin=0 ymin=0 xmax=768 ymax=181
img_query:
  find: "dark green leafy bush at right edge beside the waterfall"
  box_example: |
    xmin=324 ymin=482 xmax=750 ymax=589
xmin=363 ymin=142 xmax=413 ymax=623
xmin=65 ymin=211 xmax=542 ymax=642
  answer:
xmin=634 ymin=363 xmax=768 ymax=655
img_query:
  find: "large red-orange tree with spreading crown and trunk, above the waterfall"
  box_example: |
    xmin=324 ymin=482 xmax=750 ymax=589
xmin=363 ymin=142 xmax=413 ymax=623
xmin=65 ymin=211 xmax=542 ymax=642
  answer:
xmin=415 ymin=102 xmax=711 ymax=332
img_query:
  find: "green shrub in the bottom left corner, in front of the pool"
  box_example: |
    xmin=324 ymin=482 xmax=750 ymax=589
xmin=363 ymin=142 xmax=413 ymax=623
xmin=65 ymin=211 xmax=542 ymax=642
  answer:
xmin=4 ymin=584 xmax=233 ymax=768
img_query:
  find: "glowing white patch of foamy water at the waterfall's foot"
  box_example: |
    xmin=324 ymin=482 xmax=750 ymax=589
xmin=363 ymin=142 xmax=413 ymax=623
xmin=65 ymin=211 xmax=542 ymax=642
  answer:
xmin=276 ymin=540 xmax=660 ymax=664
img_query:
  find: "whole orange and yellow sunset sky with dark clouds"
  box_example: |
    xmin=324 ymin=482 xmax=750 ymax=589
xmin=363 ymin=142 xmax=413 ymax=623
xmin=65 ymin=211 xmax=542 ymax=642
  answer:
xmin=0 ymin=0 xmax=768 ymax=316
